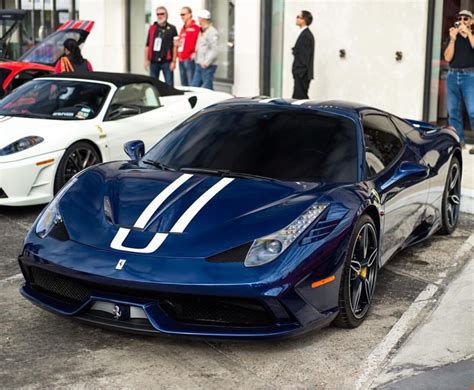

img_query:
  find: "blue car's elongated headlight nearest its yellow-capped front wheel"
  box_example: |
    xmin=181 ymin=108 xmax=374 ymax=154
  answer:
xmin=244 ymin=204 xmax=328 ymax=267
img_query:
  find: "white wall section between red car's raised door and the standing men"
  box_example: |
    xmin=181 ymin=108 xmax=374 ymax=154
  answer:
xmin=78 ymin=0 xmax=126 ymax=72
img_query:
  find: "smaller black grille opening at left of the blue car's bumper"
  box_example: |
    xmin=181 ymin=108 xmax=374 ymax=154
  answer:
xmin=30 ymin=267 xmax=91 ymax=304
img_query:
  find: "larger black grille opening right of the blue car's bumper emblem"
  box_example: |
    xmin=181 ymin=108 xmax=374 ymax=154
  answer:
xmin=161 ymin=297 xmax=275 ymax=326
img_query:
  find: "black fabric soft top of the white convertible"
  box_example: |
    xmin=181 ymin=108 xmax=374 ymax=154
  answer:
xmin=46 ymin=72 xmax=184 ymax=96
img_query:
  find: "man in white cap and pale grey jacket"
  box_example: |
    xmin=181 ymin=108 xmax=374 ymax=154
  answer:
xmin=191 ymin=10 xmax=219 ymax=89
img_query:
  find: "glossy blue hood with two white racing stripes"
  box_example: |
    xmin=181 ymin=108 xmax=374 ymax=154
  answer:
xmin=60 ymin=162 xmax=336 ymax=258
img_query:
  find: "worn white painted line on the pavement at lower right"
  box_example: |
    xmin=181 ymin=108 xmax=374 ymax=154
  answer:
xmin=355 ymin=234 xmax=474 ymax=390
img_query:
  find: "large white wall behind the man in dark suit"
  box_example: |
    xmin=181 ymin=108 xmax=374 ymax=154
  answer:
xmin=283 ymin=0 xmax=428 ymax=119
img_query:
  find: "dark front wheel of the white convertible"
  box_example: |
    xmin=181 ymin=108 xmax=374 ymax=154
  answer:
xmin=54 ymin=141 xmax=101 ymax=195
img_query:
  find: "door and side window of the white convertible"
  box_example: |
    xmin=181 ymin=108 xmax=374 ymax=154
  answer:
xmin=101 ymin=83 xmax=187 ymax=160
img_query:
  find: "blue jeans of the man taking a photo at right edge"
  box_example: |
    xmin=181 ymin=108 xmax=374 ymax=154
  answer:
xmin=446 ymin=70 xmax=474 ymax=142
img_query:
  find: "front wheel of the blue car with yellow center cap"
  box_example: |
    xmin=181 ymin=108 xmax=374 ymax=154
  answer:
xmin=334 ymin=214 xmax=379 ymax=328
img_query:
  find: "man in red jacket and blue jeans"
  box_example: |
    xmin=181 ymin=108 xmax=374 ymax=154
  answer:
xmin=178 ymin=7 xmax=200 ymax=85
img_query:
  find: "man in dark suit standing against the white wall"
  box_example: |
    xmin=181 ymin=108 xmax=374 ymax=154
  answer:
xmin=291 ymin=11 xmax=314 ymax=99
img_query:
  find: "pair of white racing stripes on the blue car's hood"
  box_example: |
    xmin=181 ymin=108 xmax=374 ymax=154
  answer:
xmin=110 ymin=174 xmax=234 ymax=253
